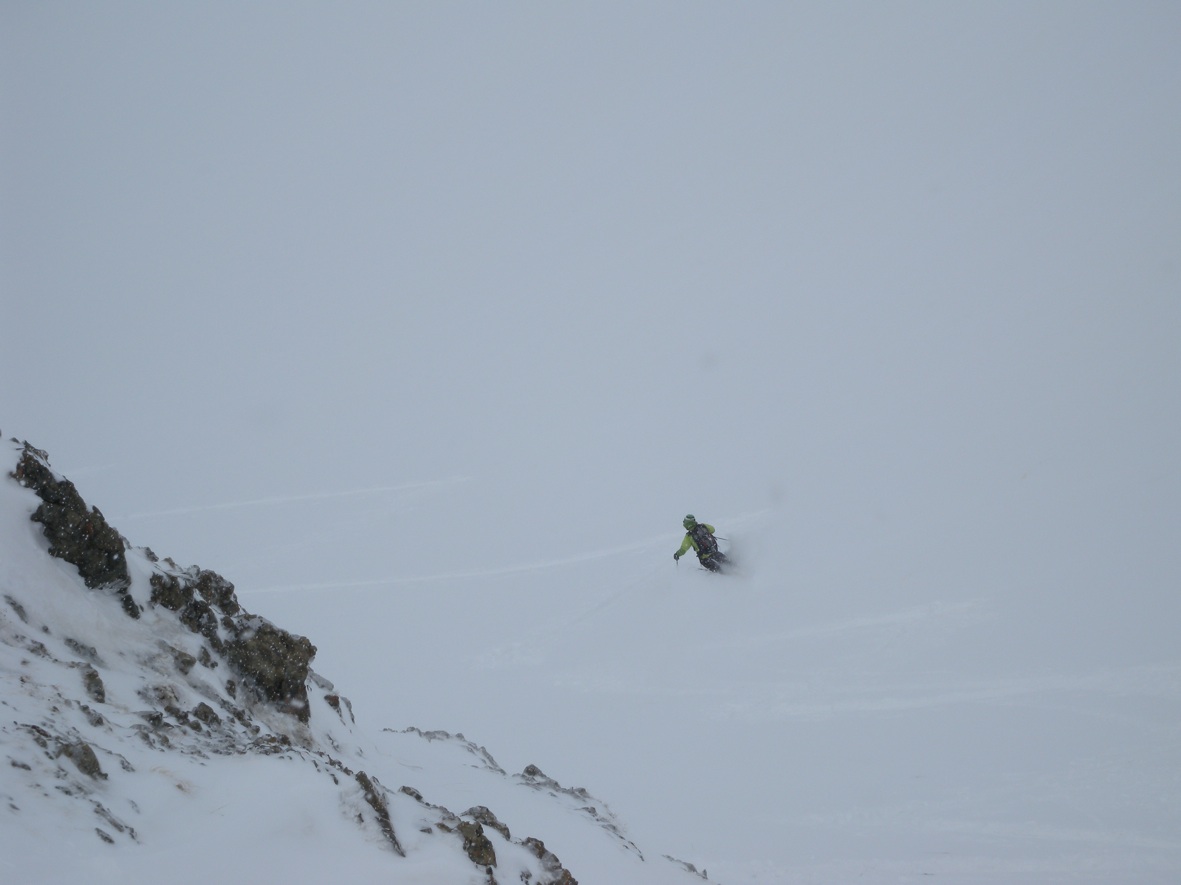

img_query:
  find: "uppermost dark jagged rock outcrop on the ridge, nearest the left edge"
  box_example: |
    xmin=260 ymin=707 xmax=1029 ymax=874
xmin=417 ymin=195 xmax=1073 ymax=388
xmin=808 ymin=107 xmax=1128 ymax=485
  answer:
xmin=13 ymin=443 xmax=139 ymax=618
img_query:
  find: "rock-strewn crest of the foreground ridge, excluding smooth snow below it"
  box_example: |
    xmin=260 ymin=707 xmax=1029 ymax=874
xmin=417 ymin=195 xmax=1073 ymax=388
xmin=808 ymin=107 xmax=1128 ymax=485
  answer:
xmin=0 ymin=441 xmax=675 ymax=885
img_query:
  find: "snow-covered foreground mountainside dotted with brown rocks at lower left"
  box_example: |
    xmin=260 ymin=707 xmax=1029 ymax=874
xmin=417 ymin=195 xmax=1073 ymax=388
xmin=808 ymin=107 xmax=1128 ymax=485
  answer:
xmin=0 ymin=441 xmax=706 ymax=885
